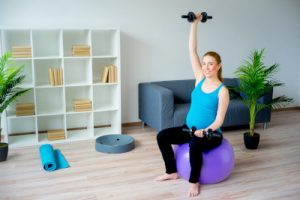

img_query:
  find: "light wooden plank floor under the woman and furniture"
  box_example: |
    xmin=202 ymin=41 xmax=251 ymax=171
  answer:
xmin=0 ymin=110 xmax=300 ymax=200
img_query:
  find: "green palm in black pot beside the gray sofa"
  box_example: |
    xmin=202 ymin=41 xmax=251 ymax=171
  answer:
xmin=230 ymin=49 xmax=292 ymax=149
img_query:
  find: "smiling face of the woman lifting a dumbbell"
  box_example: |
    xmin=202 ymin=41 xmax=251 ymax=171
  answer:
xmin=202 ymin=55 xmax=221 ymax=78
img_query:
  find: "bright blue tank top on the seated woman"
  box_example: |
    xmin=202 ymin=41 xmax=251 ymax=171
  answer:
xmin=186 ymin=78 xmax=223 ymax=132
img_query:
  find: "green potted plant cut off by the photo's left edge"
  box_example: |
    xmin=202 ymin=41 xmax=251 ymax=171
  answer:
xmin=0 ymin=52 xmax=30 ymax=162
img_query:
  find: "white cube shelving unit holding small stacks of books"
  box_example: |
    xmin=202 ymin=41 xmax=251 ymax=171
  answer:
xmin=0 ymin=29 xmax=121 ymax=147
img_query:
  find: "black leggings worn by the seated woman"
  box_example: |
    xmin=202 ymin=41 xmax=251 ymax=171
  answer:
xmin=157 ymin=125 xmax=222 ymax=183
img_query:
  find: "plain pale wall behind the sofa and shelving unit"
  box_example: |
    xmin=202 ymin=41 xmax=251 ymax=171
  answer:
xmin=0 ymin=0 xmax=300 ymax=122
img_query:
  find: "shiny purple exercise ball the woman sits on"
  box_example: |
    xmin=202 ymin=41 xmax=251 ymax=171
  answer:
xmin=174 ymin=138 xmax=234 ymax=184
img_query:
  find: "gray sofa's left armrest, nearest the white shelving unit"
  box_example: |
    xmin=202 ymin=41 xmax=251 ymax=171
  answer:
xmin=138 ymin=83 xmax=174 ymax=131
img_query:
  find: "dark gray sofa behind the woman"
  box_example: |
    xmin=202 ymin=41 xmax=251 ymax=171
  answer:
xmin=138 ymin=78 xmax=273 ymax=131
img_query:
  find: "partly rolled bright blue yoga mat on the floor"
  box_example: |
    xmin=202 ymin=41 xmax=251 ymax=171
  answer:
xmin=40 ymin=144 xmax=70 ymax=172
